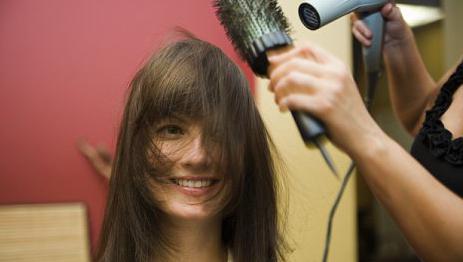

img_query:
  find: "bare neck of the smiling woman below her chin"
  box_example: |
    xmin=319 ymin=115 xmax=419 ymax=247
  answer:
xmin=159 ymin=219 xmax=227 ymax=262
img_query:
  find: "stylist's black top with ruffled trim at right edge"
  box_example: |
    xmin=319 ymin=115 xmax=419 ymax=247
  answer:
xmin=411 ymin=61 xmax=463 ymax=197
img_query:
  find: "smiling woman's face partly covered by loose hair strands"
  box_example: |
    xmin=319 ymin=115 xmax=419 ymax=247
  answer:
xmin=152 ymin=118 xmax=227 ymax=220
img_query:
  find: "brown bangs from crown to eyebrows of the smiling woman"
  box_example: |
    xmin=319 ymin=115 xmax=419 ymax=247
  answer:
xmin=145 ymin=39 xmax=241 ymax=126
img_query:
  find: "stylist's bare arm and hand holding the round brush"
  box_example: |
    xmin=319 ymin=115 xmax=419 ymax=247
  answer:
xmin=269 ymin=43 xmax=463 ymax=261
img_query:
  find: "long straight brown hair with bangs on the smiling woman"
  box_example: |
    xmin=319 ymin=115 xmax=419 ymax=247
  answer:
xmin=97 ymin=37 xmax=286 ymax=262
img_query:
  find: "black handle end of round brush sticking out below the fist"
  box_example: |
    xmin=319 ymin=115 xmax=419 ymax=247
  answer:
xmin=291 ymin=111 xmax=326 ymax=146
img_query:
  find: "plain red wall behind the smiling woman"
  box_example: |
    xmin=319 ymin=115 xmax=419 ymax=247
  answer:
xmin=0 ymin=0 xmax=252 ymax=252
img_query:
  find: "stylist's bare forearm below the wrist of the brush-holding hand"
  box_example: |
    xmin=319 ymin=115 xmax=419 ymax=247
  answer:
xmin=352 ymin=135 xmax=463 ymax=261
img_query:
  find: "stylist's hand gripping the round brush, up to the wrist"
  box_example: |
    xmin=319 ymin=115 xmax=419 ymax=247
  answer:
xmin=269 ymin=43 xmax=382 ymax=157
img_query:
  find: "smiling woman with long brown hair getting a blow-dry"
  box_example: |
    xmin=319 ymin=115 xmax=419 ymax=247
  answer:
xmin=97 ymin=35 xmax=286 ymax=262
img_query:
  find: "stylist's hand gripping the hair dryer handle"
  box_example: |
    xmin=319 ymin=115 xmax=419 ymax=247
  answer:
xmin=351 ymin=3 xmax=413 ymax=51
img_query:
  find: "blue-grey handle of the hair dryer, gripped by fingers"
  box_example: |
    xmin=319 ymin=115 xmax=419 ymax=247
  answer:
xmin=362 ymin=12 xmax=384 ymax=73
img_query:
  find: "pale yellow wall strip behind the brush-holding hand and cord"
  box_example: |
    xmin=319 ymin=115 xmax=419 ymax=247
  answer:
xmin=256 ymin=0 xmax=357 ymax=262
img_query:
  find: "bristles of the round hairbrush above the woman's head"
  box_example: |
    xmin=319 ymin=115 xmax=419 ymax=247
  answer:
xmin=214 ymin=0 xmax=289 ymax=62
